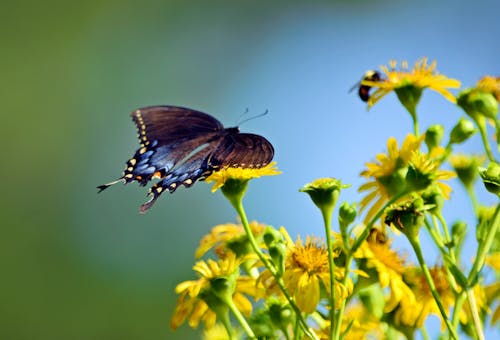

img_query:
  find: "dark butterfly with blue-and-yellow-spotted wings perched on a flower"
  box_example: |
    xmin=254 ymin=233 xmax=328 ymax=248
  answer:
xmin=97 ymin=106 xmax=274 ymax=213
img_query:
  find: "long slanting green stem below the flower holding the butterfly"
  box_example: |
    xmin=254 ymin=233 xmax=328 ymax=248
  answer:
xmin=226 ymin=196 xmax=318 ymax=340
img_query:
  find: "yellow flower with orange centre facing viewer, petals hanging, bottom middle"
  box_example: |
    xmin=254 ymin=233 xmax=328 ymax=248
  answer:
xmin=261 ymin=228 xmax=352 ymax=314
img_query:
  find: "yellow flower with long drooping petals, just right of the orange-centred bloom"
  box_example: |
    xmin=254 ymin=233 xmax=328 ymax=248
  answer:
xmin=355 ymin=228 xmax=415 ymax=312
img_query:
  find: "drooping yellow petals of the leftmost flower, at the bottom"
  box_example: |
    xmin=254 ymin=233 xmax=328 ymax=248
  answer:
xmin=170 ymin=256 xmax=261 ymax=329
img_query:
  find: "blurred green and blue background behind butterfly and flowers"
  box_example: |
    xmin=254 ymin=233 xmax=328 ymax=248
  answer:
xmin=0 ymin=0 xmax=500 ymax=340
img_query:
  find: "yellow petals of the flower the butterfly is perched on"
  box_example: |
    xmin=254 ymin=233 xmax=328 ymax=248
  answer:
xmin=205 ymin=162 xmax=281 ymax=192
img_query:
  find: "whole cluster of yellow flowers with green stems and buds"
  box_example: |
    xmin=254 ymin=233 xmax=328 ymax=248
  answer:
xmin=166 ymin=58 xmax=500 ymax=339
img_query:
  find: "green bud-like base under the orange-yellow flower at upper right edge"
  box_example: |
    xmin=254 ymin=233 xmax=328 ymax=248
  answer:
xmin=457 ymin=89 xmax=498 ymax=120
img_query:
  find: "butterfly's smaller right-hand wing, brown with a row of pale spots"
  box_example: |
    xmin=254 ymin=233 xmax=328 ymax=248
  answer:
xmin=209 ymin=133 xmax=274 ymax=168
